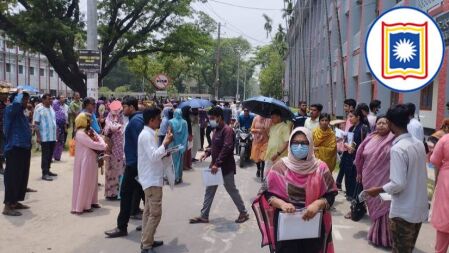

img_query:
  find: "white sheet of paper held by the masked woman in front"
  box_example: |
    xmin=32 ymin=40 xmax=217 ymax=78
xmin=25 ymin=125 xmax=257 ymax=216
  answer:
xmin=277 ymin=210 xmax=323 ymax=241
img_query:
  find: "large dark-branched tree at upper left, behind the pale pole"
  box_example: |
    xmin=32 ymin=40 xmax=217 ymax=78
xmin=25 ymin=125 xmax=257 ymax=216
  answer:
xmin=0 ymin=0 xmax=206 ymax=95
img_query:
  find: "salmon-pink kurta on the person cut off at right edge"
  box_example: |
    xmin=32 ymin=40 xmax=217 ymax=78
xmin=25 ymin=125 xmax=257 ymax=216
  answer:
xmin=430 ymin=134 xmax=449 ymax=233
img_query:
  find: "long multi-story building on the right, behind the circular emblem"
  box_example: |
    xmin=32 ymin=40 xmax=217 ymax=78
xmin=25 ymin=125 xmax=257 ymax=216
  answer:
xmin=284 ymin=0 xmax=449 ymax=129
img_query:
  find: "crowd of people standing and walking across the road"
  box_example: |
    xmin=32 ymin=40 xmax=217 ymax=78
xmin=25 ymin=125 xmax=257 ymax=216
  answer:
xmin=0 ymin=91 xmax=449 ymax=253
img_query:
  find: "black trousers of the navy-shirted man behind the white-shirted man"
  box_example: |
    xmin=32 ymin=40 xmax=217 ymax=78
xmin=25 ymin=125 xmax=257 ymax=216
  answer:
xmin=117 ymin=166 xmax=143 ymax=230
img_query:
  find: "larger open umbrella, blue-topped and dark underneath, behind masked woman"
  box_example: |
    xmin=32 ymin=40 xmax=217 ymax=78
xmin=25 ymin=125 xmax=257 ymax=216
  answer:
xmin=242 ymin=96 xmax=295 ymax=120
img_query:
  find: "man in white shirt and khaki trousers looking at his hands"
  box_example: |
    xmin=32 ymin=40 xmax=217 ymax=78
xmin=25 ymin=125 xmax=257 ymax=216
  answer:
xmin=137 ymin=108 xmax=173 ymax=253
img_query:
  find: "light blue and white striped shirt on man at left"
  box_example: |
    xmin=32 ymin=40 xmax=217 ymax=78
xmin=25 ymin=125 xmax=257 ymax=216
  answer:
xmin=34 ymin=106 xmax=56 ymax=142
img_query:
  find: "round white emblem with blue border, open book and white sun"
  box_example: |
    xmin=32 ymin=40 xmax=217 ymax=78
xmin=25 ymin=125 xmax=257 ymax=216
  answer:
xmin=365 ymin=7 xmax=444 ymax=92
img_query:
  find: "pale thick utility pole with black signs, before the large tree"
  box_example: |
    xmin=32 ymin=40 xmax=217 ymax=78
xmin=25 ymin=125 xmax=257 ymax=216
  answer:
xmin=86 ymin=0 xmax=98 ymax=99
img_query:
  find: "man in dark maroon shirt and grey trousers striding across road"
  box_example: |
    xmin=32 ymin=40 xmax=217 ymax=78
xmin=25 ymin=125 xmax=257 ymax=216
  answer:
xmin=190 ymin=107 xmax=249 ymax=224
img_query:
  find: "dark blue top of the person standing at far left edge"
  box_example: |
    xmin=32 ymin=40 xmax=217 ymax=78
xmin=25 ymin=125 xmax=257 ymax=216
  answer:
xmin=3 ymin=93 xmax=31 ymax=153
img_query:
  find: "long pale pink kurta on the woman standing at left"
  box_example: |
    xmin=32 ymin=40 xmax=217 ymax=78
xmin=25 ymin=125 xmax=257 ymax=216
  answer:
xmin=72 ymin=129 xmax=106 ymax=212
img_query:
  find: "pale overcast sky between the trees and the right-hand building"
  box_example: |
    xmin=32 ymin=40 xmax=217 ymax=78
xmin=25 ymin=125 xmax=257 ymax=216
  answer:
xmin=80 ymin=0 xmax=285 ymax=46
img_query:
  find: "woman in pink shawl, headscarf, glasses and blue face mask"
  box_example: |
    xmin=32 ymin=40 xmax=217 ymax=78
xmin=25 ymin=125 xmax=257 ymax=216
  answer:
xmin=253 ymin=127 xmax=338 ymax=253
